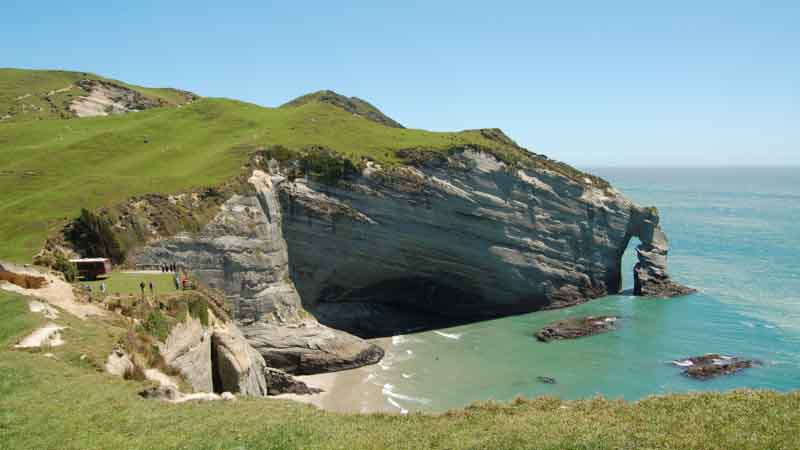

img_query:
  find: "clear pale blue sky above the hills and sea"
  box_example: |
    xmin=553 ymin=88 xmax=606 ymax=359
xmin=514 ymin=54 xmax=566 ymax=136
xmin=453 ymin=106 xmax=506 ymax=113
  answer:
xmin=0 ymin=0 xmax=800 ymax=167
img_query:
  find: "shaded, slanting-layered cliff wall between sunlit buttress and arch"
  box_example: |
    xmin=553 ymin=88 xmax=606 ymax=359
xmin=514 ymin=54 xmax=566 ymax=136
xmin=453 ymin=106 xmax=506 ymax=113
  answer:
xmin=280 ymin=148 xmax=692 ymax=330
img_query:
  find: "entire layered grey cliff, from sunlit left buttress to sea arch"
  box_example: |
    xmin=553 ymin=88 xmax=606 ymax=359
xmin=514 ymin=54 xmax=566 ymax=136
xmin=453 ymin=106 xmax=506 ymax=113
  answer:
xmin=131 ymin=148 xmax=688 ymax=373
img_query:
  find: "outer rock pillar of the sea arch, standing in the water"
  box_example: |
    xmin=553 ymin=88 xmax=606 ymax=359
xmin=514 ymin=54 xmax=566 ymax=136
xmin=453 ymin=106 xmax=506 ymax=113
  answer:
xmin=631 ymin=209 xmax=696 ymax=298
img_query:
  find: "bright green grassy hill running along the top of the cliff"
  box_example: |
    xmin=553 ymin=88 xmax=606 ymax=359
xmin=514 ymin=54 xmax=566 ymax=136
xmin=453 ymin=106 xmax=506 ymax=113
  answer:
xmin=0 ymin=69 xmax=574 ymax=262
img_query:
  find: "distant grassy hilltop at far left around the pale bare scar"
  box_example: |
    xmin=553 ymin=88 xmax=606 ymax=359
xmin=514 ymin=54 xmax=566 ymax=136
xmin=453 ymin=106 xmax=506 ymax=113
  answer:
xmin=0 ymin=68 xmax=191 ymax=122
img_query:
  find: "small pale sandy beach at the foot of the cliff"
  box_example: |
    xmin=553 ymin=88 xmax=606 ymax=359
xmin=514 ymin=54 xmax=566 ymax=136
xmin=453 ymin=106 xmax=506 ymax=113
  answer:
xmin=276 ymin=338 xmax=400 ymax=413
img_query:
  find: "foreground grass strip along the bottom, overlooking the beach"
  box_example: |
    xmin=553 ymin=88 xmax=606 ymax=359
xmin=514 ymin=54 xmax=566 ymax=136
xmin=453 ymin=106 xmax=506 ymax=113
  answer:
xmin=0 ymin=293 xmax=800 ymax=450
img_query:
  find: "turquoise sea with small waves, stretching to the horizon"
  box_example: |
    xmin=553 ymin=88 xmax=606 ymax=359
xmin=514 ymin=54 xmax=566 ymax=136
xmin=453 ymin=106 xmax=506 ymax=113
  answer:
xmin=365 ymin=168 xmax=800 ymax=411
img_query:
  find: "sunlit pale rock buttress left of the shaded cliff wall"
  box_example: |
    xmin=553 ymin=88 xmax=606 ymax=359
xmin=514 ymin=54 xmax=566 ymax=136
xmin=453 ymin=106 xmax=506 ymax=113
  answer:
xmin=129 ymin=170 xmax=383 ymax=373
